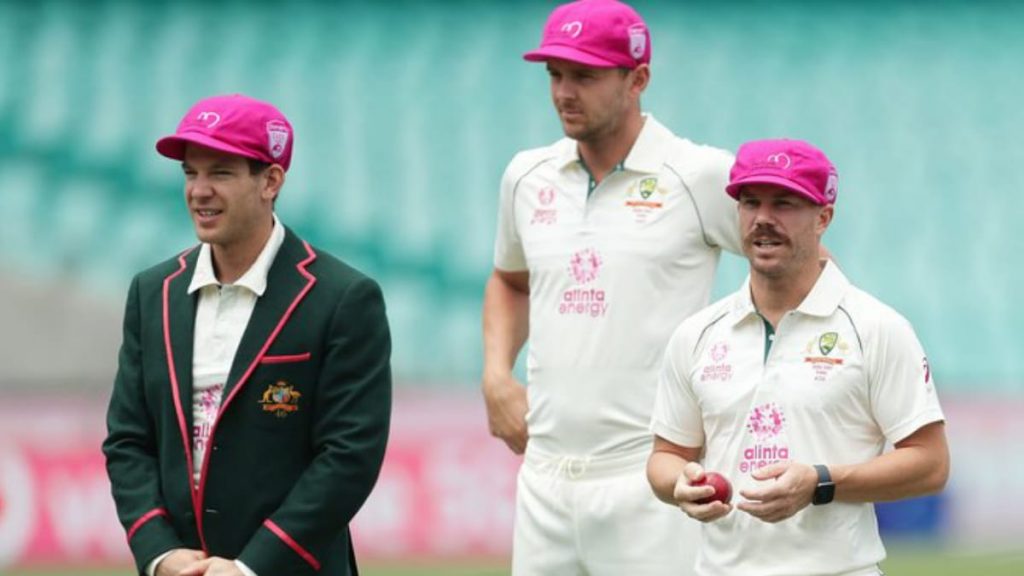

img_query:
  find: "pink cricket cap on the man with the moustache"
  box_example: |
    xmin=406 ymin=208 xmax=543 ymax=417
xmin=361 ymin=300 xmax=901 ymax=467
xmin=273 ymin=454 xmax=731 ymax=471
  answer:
xmin=725 ymin=139 xmax=839 ymax=206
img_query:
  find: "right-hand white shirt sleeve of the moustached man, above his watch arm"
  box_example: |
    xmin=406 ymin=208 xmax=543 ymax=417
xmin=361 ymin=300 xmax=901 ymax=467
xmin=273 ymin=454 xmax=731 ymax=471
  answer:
xmin=866 ymin=313 xmax=945 ymax=443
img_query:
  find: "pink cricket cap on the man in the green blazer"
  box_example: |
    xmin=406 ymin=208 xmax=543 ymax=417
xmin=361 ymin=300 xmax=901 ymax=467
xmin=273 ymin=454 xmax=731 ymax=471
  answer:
xmin=157 ymin=94 xmax=294 ymax=172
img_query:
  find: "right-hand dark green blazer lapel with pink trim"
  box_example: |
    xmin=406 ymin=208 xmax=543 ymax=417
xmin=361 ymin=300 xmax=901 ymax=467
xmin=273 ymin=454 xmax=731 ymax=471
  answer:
xmin=221 ymin=227 xmax=316 ymax=411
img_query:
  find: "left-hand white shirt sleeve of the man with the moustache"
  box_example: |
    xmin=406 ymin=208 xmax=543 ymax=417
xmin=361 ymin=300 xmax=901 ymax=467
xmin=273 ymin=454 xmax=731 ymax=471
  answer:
xmin=650 ymin=331 xmax=705 ymax=448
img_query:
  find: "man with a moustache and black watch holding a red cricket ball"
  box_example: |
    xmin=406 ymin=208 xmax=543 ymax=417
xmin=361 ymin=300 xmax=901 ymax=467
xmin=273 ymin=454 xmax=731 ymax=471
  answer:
xmin=647 ymin=139 xmax=949 ymax=576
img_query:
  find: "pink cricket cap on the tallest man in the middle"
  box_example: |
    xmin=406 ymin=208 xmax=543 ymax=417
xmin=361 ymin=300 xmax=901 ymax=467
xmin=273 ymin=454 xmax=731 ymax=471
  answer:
xmin=522 ymin=0 xmax=650 ymax=70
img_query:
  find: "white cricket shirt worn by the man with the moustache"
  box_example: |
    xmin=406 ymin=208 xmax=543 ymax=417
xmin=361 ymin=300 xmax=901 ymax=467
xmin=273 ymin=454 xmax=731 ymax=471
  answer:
xmin=651 ymin=261 xmax=944 ymax=576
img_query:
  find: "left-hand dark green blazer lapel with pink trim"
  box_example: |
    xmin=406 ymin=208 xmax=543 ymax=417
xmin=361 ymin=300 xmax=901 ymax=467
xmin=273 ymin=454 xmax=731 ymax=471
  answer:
xmin=163 ymin=248 xmax=199 ymax=459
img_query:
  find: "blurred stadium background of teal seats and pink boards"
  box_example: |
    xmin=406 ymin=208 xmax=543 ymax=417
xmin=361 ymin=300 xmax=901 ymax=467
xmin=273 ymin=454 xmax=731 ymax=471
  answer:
xmin=0 ymin=0 xmax=1024 ymax=575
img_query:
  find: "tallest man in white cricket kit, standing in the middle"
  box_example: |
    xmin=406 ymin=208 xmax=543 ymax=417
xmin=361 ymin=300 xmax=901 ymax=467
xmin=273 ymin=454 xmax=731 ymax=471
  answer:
xmin=482 ymin=0 xmax=739 ymax=576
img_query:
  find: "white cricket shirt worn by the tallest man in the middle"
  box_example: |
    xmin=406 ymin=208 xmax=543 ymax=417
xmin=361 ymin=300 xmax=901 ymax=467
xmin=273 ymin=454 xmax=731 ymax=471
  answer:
xmin=495 ymin=115 xmax=739 ymax=456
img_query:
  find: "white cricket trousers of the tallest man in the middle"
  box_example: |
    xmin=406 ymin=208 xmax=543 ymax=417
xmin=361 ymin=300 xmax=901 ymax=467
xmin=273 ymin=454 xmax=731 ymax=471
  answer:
xmin=512 ymin=448 xmax=700 ymax=576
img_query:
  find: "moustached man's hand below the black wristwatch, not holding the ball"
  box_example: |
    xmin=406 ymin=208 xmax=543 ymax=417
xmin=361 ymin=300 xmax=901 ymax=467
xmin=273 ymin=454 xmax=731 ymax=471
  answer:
xmin=736 ymin=461 xmax=818 ymax=523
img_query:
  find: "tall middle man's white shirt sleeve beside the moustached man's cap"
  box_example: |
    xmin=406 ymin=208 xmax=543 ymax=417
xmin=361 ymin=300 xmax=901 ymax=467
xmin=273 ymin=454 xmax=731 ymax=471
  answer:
xmin=689 ymin=148 xmax=742 ymax=254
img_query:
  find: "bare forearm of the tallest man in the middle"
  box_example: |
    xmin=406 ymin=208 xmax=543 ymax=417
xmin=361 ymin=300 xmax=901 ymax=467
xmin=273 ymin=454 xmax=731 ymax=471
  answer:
xmin=483 ymin=272 xmax=529 ymax=373
